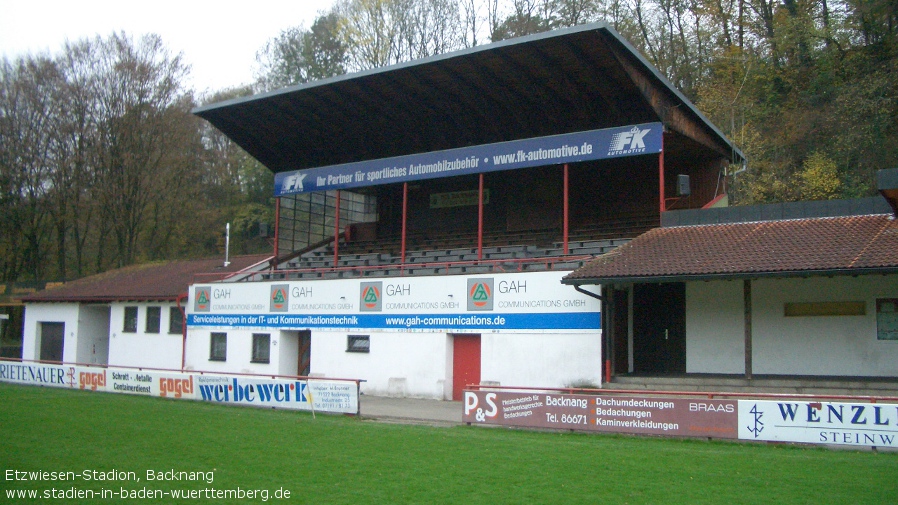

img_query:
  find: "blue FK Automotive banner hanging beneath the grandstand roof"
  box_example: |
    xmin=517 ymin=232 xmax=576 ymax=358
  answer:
xmin=274 ymin=123 xmax=663 ymax=196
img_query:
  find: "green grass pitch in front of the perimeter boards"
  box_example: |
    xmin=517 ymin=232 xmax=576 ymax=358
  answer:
xmin=0 ymin=384 xmax=898 ymax=505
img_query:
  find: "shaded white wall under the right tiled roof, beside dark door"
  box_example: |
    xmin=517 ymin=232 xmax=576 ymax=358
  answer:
xmin=686 ymin=275 xmax=898 ymax=377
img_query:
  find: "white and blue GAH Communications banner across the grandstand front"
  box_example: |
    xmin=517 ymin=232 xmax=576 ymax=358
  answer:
xmin=187 ymin=272 xmax=601 ymax=332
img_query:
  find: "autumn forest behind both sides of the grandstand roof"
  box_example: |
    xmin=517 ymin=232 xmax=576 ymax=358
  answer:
xmin=0 ymin=0 xmax=898 ymax=282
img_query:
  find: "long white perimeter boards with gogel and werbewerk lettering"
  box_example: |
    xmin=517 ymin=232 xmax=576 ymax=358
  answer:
xmin=0 ymin=362 xmax=359 ymax=414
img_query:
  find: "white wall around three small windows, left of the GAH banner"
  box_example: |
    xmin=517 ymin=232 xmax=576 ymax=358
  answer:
xmin=109 ymin=302 xmax=182 ymax=370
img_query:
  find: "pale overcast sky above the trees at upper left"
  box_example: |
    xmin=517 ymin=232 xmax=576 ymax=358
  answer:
xmin=0 ymin=0 xmax=334 ymax=93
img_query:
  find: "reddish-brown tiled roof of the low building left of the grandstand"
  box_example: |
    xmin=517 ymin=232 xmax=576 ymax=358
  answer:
xmin=22 ymin=254 xmax=271 ymax=302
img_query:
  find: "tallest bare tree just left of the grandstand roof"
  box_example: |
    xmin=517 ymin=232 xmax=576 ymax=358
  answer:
xmin=88 ymin=34 xmax=190 ymax=266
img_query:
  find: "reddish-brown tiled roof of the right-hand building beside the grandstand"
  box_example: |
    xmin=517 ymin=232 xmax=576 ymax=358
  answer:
xmin=562 ymin=214 xmax=898 ymax=284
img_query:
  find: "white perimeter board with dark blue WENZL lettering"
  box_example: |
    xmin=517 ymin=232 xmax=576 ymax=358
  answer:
xmin=739 ymin=400 xmax=898 ymax=447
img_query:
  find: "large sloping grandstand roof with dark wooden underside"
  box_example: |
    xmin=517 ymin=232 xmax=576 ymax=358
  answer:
xmin=194 ymin=24 xmax=743 ymax=176
